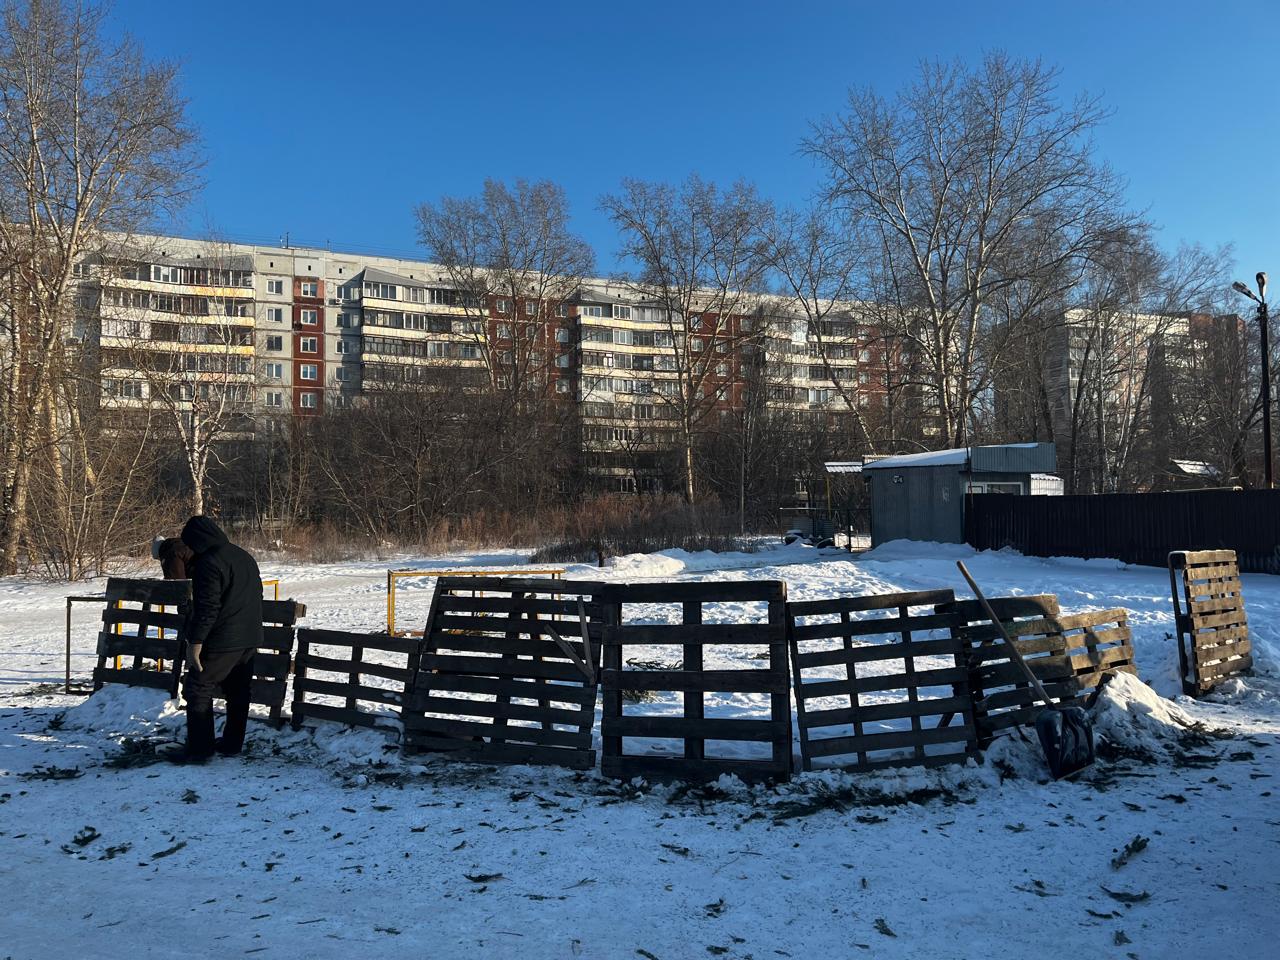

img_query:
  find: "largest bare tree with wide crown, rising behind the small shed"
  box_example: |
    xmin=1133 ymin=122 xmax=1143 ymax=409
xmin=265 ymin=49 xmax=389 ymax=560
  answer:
xmin=805 ymin=54 xmax=1129 ymax=445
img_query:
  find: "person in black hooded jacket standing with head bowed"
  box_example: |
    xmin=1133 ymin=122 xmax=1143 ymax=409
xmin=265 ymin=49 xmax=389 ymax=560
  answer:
xmin=169 ymin=516 xmax=262 ymax=763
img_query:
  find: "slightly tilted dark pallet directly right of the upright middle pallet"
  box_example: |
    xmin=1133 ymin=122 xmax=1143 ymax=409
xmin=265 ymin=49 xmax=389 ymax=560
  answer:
xmin=787 ymin=590 xmax=978 ymax=771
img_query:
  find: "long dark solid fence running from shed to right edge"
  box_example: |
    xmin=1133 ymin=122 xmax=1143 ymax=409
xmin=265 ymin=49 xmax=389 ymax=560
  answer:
xmin=965 ymin=490 xmax=1280 ymax=573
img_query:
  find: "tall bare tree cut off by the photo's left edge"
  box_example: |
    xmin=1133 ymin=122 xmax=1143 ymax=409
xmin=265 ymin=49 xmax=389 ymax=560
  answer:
xmin=0 ymin=0 xmax=196 ymax=572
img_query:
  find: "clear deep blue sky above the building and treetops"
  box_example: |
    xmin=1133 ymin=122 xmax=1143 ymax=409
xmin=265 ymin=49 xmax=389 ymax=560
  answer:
xmin=122 ymin=0 xmax=1280 ymax=285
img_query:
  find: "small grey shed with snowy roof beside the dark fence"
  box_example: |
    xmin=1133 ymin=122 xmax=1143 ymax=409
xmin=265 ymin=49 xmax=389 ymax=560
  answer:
xmin=863 ymin=443 xmax=1062 ymax=547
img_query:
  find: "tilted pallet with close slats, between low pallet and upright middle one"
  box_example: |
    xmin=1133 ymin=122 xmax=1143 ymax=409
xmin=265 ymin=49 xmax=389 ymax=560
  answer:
xmin=403 ymin=577 xmax=602 ymax=769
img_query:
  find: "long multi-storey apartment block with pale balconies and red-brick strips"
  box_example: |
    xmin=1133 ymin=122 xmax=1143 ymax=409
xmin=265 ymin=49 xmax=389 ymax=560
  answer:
xmin=78 ymin=237 xmax=886 ymax=492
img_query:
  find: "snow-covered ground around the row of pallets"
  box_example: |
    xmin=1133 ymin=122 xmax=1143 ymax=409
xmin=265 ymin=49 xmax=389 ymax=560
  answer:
xmin=0 ymin=544 xmax=1280 ymax=960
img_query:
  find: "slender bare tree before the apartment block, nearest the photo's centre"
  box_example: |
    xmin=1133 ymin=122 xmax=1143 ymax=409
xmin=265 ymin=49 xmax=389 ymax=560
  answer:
xmin=602 ymin=177 xmax=769 ymax=503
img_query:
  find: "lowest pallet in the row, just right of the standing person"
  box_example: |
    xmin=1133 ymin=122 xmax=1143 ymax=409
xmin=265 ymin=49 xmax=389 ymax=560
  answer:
xmin=291 ymin=627 xmax=417 ymax=732
